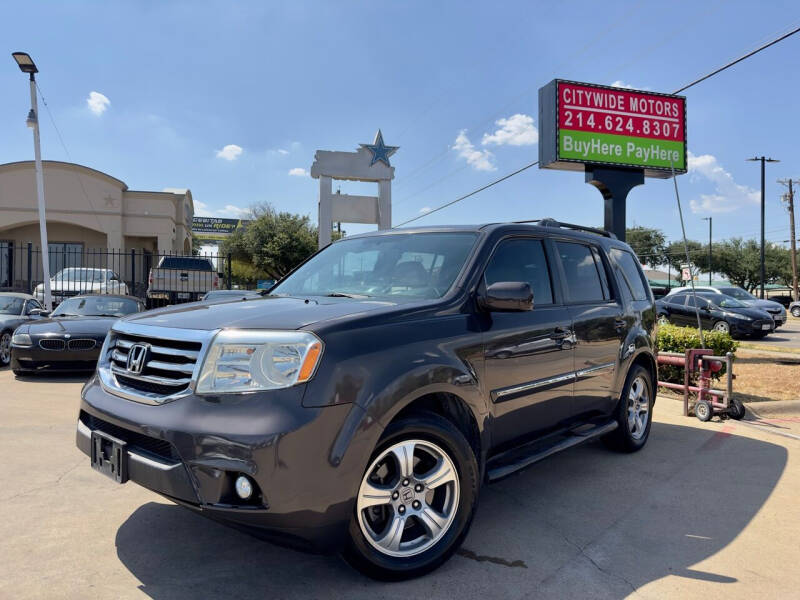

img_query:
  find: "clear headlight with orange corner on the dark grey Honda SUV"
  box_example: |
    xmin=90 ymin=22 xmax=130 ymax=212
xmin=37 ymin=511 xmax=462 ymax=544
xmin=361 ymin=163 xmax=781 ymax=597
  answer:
xmin=196 ymin=330 xmax=322 ymax=394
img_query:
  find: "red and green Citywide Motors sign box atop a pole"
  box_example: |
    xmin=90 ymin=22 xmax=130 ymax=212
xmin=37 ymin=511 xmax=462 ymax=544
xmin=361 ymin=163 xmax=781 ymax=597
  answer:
xmin=539 ymin=79 xmax=686 ymax=178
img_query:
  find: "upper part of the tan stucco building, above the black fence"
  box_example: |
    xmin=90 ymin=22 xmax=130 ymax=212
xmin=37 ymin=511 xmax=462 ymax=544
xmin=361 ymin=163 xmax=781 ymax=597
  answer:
xmin=0 ymin=160 xmax=194 ymax=254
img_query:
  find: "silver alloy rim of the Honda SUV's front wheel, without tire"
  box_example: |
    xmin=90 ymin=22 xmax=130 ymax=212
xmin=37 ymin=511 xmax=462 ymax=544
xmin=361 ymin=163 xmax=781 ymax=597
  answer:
xmin=356 ymin=439 xmax=459 ymax=558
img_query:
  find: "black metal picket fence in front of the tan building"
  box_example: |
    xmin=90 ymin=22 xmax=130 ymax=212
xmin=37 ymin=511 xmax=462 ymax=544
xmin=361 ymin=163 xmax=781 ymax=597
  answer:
xmin=0 ymin=242 xmax=233 ymax=308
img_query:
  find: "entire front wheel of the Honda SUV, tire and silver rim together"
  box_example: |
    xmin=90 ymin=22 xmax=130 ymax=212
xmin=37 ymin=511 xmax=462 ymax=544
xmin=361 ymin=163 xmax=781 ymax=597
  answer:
xmin=343 ymin=412 xmax=480 ymax=581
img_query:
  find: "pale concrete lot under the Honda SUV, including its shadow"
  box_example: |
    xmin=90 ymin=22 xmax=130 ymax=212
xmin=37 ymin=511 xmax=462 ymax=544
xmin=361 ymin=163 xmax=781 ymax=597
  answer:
xmin=0 ymin=370 xmax=800 ymax=600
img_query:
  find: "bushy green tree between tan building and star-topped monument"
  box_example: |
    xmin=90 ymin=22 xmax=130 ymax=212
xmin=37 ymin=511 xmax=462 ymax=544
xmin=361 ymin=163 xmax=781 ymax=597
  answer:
xmin=221 ymin=204 xmax=317 ymax=279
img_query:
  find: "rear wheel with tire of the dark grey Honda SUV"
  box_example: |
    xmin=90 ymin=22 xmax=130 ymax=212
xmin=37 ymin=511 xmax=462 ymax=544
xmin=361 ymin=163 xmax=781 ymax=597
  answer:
xmin=603 ymin=365 xmax=655 ymax=452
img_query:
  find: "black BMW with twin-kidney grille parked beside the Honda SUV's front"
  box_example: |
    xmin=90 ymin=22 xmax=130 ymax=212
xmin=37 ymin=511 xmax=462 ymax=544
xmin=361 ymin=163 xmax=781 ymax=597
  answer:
xmin=11 ymin=294 xmax=144 ymax=375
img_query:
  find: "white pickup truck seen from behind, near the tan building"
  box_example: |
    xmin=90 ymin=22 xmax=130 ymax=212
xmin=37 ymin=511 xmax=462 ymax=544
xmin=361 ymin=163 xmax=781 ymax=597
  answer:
xmin=147 ymin=256 xmax=219 ymax=304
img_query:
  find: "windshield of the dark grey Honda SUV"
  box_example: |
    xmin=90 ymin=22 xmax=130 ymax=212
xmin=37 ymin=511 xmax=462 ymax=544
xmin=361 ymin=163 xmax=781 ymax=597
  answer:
xmin=270 ymin=232 xmax=477 ymax=300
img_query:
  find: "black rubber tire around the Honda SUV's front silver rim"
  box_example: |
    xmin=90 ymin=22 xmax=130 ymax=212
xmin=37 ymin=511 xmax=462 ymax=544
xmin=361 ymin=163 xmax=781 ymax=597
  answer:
xmin=342 ymin=412 xmax=480 ymax=581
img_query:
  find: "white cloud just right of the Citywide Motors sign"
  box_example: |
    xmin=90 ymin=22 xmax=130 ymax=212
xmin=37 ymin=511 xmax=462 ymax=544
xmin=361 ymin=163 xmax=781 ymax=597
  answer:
xmin=688 ymin=152 xmax=761 ymax=213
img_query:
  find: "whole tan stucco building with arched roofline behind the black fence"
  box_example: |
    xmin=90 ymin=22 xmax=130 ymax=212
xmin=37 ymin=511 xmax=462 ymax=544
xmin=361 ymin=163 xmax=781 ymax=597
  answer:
xmin=0 ymin=160 xmax=194 ymax=290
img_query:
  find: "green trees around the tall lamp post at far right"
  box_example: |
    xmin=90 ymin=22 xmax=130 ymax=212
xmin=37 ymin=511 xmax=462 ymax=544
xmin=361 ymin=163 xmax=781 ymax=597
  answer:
xmin=714 ymin=238 xmax=791 ymax=292
